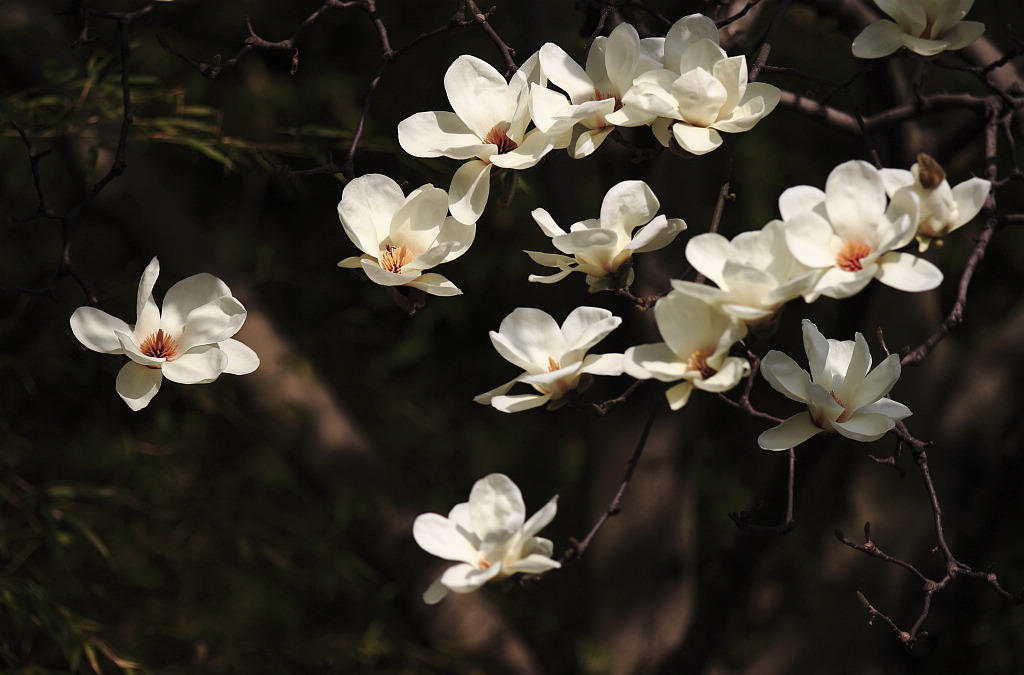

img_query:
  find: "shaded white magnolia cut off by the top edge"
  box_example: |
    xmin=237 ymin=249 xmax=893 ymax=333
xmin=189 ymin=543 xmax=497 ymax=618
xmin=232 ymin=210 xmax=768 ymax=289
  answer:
xmin=853 ymin=0 xmax=985 ymax=58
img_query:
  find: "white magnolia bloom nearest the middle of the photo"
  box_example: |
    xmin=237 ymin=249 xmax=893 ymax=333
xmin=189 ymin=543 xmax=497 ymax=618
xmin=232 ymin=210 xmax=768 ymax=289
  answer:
xmin=473 ymin=307 xmax=623 ymax=413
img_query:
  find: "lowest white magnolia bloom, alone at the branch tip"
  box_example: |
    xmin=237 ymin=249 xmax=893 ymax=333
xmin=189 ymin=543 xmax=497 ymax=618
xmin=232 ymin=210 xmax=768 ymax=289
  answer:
xmin=413 ymin=473 xmax=561 ymax=604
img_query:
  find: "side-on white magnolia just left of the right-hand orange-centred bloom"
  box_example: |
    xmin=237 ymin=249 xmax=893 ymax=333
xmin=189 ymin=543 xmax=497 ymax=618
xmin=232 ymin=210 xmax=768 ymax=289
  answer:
xmin=672 ymin=220 xmax=821 ymax=327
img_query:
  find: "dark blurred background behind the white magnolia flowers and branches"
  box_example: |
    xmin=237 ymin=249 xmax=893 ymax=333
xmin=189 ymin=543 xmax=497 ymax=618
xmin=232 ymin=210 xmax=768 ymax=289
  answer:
xmin=6 ymin=0 xmax=1024 ymax=674
